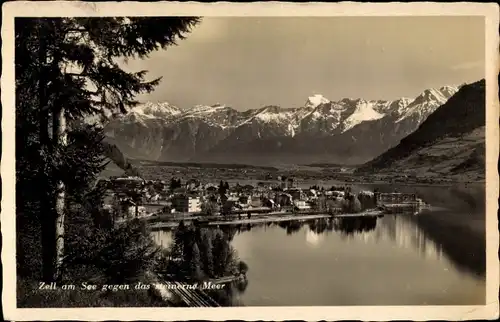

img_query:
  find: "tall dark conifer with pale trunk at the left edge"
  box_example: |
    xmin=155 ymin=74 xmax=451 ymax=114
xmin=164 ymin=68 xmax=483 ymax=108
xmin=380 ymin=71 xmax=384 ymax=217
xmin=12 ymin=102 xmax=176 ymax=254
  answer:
xmin=15 ymin=17 xmax=199 ymax=281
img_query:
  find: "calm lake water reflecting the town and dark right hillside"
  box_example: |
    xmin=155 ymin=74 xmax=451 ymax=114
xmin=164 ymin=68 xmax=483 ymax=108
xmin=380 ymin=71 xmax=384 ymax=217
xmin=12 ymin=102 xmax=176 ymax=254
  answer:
xmin=153 ymin=186 xmax=485 ymax=306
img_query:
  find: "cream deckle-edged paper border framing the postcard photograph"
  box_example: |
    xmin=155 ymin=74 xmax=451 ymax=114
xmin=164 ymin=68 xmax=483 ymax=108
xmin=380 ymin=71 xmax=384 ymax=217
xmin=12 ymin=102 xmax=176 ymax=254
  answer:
xmin=1 ymin=1 xmax=500 ymax=321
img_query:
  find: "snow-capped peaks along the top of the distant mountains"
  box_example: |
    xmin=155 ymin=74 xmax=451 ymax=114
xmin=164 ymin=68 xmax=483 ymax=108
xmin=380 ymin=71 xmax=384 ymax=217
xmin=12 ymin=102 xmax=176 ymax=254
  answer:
xmin=109 ymin=82 xmax=458 ymax=137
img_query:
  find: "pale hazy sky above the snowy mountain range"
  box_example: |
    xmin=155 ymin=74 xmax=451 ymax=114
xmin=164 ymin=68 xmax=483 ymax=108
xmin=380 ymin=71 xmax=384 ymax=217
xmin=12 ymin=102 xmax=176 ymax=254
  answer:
xmin=125 ymin=16 xmax=485 ymax=110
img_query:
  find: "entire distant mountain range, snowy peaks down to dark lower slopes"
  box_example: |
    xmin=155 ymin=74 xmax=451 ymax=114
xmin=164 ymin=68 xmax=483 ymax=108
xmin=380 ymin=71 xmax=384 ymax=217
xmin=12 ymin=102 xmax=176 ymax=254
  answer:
xmin=105 ymin=86 xmax=459 ymax=165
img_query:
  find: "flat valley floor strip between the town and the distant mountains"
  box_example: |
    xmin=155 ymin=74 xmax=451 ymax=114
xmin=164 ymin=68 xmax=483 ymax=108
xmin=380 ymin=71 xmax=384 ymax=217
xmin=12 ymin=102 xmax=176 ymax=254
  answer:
xmin=106 ymin=160 xmax=484 ymax=187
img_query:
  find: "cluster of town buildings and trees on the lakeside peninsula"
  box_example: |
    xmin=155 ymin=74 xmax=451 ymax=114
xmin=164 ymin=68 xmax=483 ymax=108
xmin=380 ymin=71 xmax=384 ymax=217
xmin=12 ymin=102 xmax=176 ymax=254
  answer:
xmin=99 ymin=177 xmax=390 ymax=217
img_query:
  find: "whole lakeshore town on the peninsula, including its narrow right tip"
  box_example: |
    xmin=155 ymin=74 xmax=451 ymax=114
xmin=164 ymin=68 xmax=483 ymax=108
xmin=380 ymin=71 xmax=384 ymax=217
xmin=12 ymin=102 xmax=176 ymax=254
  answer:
xmin=97 ymin=176 xmax=426 ymax=227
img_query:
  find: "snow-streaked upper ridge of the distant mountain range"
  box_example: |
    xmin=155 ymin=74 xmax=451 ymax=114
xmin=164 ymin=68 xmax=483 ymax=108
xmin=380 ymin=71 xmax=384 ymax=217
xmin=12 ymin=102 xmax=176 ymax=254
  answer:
xmin=119 ymin=86 xmax=458 ymax=133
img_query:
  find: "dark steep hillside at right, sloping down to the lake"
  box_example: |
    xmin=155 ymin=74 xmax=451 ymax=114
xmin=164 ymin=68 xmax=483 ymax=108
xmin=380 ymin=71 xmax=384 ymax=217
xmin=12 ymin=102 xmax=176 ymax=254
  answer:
xmin=357 ymin=80 xmax=486 ymax=179
